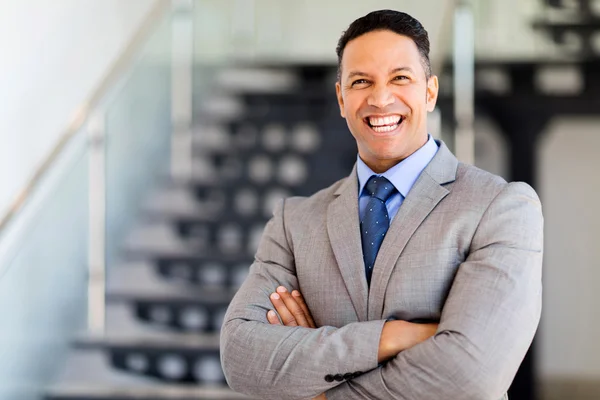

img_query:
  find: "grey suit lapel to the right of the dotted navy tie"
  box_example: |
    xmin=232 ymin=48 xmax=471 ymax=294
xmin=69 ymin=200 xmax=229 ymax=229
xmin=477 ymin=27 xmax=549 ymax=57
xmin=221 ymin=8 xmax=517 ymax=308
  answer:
xmin=366 ymin=142 xmax=458 ymax=320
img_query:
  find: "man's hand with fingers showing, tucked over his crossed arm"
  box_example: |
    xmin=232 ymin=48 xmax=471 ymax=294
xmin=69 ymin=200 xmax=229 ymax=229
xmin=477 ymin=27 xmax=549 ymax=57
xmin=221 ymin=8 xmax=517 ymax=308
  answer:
xmin=267 ymin=286 xmax=317 ymax=328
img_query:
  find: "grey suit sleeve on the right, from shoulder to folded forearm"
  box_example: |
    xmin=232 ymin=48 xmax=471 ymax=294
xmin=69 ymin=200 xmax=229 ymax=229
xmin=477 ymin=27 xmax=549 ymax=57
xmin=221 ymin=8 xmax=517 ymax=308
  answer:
xmin=326 ymin=183 xmax=543 ymax=400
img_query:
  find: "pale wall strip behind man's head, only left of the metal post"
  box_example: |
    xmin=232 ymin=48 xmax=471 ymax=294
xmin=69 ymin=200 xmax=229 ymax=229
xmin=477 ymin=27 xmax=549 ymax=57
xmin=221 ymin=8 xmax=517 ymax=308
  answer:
xmin=194 ymin=0 xmax=450 ymax=63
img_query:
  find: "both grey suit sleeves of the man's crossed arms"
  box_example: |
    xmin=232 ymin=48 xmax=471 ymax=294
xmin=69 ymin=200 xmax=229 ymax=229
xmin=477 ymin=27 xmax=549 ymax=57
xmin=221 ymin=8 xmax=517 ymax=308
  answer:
xmin=221 ymin=184 xmax=543 ymax=400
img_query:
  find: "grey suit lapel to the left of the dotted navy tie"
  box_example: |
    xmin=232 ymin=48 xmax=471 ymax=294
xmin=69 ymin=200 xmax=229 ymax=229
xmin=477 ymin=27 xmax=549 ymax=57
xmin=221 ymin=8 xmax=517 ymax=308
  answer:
xmin=327 ymin=166 xmax=368 ymax=321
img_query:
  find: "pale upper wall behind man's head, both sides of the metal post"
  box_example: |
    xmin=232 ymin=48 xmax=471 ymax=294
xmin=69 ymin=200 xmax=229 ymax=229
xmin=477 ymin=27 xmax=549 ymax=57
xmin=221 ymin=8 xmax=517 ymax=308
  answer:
xmin=194 ymin=0 xmax=561 ymax=63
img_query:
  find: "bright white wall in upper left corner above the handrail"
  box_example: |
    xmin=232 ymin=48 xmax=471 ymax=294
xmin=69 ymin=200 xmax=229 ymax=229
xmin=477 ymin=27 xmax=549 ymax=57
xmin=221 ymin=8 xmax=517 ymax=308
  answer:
xmin=0 ymin=0 xmax=154 ymax=217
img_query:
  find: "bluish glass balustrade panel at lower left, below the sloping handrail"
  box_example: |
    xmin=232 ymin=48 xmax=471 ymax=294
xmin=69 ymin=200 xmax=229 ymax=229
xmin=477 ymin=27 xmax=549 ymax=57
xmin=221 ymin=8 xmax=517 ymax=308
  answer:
xmin=0 ymin=138 xmax=88 ymax=400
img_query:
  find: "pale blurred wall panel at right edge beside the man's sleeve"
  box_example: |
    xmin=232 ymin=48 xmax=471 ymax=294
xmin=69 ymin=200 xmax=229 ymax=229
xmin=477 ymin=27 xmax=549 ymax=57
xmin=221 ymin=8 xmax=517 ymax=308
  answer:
xmin=538 ymin=118 xmax=600 ymax=380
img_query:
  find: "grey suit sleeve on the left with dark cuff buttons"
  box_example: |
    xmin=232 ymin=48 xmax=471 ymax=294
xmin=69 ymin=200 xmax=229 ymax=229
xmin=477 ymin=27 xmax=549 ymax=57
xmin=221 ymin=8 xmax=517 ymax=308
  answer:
xmin=221 ymin=198 xmax=384 ymax=399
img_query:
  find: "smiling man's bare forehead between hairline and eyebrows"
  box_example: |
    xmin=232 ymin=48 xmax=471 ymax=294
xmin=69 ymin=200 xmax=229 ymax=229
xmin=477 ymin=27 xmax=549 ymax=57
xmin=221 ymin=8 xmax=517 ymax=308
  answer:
xmin=342 ymin=30 xmax=422 ymax=75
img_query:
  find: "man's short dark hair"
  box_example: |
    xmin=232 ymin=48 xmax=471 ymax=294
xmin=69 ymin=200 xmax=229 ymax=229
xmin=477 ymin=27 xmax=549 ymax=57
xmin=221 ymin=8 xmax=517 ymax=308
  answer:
xmin=335 ymin=10 xmax=431 ymax=80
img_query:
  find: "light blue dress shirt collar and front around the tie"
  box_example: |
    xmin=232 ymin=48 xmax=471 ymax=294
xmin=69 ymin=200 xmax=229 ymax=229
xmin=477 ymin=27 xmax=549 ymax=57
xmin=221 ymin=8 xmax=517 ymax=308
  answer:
xmin=356 ymin=135 xmax=439 ymax=223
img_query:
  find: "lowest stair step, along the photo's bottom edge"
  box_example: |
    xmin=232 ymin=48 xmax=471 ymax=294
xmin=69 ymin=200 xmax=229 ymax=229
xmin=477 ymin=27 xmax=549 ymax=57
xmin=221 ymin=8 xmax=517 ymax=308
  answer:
xmin=45 ymin=385 xmax=250 ymax=400
